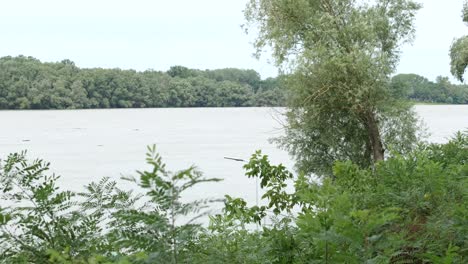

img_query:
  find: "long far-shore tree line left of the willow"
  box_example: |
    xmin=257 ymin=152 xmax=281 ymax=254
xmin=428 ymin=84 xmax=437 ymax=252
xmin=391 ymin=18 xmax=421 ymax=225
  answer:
xmin=0 ymin=56 xmax=285 ymax=109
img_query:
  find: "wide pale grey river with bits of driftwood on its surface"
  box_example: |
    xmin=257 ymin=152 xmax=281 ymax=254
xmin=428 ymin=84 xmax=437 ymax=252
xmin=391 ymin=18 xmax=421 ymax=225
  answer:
xmin=0 ymin=105 xmax=468 ymax=210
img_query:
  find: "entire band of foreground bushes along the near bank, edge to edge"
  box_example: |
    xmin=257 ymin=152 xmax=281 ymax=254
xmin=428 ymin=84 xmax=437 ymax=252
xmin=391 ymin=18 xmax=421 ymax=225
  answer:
xmin=0 ymin=133 xmax=468 ymax=264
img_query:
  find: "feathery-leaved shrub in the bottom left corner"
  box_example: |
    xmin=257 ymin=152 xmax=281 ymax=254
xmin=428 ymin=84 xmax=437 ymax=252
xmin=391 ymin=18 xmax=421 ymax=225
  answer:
xmin=0 ymin=152 xmax=99 ymax=263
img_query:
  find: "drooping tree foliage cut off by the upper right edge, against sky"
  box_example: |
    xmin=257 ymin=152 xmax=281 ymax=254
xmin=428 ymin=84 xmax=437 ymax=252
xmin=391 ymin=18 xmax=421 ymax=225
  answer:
xmin=450 ymin=1 xmax=468 ymax=82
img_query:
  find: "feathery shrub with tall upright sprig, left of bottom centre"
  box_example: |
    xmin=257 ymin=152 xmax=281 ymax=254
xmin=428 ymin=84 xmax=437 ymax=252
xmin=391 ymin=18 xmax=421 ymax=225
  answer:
xmin=103 ymin=146 xmax=224 ymax=263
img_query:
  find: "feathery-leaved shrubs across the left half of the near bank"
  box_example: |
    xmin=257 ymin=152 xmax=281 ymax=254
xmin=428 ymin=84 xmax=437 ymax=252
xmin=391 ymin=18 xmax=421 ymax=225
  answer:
xmin=0 ymin=147 xmax=219 ymax=263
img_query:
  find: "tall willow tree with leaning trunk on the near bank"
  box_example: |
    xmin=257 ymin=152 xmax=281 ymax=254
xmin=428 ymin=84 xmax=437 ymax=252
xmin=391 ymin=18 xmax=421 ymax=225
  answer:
xmin=244 ymin=0 xmax=420 ymax=176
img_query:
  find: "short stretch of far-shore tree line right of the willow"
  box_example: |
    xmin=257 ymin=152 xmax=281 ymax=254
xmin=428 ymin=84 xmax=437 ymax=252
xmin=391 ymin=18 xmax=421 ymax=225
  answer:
xmin=392 ymin=74 xmax=468 ymax=104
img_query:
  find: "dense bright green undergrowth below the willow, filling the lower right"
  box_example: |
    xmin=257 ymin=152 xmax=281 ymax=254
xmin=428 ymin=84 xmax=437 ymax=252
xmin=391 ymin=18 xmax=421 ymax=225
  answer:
xmin=206 ymin=133 xmax=468 ymax=263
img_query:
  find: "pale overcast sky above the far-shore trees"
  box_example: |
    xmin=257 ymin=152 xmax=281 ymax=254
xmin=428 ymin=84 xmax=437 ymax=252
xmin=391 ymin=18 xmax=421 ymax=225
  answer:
xmin=0 ymin=0 xmax=468 ymax=80
